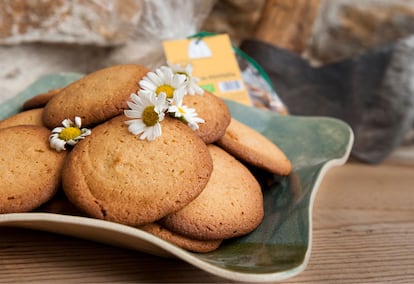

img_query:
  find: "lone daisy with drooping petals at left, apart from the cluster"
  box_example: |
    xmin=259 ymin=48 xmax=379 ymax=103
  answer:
xmin=49 ymin=116 xmax=91 ymax=152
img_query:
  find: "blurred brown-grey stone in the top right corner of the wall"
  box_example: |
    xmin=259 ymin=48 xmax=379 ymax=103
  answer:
xmin=306 ymin=0 xmax=414 ymax=63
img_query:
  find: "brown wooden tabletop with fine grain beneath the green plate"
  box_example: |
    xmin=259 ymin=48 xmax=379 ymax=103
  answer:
xmin=0 ymin=158 xmax=414 ymax=283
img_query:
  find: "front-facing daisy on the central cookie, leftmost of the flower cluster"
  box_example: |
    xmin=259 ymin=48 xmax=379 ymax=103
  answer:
xmin=124 ymin=90 xmax=168 ymax=141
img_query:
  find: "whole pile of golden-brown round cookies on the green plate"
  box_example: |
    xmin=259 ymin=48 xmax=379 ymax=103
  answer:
xmin=0 ymin=64 xmax=291 ymax=252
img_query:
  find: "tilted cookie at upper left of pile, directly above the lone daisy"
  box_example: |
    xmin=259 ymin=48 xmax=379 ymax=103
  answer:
xmin=43 ymin=64 xmax=149 ymax=129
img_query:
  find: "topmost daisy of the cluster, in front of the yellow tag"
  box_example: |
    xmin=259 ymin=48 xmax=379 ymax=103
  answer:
xmin=139 ymin=66 xmax=187 ymax=99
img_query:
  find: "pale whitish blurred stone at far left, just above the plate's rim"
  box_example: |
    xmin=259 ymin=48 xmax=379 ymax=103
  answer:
xmin=0 ymin=44 xmax=111 ymax=103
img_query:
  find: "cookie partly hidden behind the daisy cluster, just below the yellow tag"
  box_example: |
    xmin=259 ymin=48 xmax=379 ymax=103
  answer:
xmin=183 ymin=91 xmax=231 ymax=144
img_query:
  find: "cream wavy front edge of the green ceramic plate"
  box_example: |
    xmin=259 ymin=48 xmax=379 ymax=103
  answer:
xmin=0 ymin=127 xmax=354 ymax=282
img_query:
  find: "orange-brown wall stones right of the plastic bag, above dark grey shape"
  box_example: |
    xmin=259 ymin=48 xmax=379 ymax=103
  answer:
xmin=202 ymin=0 xmax=414 ymax=64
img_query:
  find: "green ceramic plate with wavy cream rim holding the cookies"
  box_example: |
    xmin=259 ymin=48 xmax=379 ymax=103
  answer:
xmin=0 ymin=74 xmax=353 ymax=282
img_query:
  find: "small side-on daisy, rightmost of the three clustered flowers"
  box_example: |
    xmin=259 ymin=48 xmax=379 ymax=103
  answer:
xmin=168 ymin=91 xmax=204 ymax=130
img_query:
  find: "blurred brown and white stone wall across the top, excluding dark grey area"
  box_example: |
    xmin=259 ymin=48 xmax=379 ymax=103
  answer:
xmin=0 ymin=0 xmax=414 ymax=97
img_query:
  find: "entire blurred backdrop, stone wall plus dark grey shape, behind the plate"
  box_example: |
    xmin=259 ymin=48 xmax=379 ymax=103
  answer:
xmin=0 ymin=0 xmax=414 ymax=164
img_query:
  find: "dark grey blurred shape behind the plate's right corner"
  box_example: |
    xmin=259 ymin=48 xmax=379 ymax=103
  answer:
xmin=241 ymin=36 xmax=414 ymax=163
